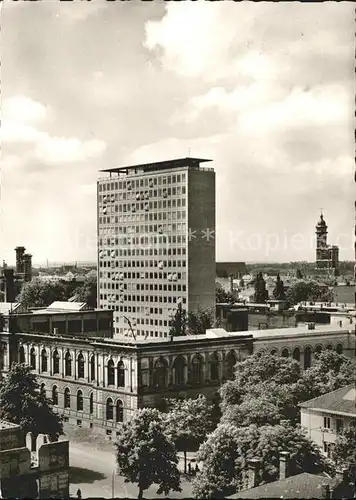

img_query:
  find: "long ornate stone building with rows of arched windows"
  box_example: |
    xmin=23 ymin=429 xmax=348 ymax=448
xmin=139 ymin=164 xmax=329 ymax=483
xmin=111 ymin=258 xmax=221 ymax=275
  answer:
xmin=0 ymin=325 xmax=355 ymax=435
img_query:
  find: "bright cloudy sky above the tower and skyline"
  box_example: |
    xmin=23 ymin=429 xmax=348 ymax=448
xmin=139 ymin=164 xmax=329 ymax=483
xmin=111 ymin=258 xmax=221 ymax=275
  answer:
xmin=0 ymin=0 xmax=355 ymax=264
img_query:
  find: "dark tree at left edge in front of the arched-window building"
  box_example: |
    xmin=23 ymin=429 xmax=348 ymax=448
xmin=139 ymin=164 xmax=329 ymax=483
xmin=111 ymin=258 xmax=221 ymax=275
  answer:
xmin=0 ymin=363 xmax=63 ymax=441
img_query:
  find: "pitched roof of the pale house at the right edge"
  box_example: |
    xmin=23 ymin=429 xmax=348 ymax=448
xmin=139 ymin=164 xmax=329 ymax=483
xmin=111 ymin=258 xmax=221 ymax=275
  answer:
xmin=299 ymin=384 xmax=356 ymax=416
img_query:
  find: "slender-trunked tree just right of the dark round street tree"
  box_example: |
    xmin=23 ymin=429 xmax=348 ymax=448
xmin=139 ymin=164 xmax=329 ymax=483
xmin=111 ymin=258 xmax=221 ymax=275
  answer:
xmin=165 ymin=396 xmax=214 ymax=473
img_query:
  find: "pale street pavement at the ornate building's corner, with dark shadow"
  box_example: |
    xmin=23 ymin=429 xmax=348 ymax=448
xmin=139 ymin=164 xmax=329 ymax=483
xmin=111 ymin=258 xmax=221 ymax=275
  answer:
xmin=69 ymin=441 xmax=192 ymax=499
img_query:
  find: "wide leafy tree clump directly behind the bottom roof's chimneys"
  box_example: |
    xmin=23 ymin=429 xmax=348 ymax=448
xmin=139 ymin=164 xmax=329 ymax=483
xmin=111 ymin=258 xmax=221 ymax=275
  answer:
xmin=193 ymin=421 xmax=334 ymax=498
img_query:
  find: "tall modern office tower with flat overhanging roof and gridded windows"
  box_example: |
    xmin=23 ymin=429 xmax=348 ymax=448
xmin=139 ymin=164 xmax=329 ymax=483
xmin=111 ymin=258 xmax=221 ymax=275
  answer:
xmin=97 ymin=158 xmax=215 ymax=338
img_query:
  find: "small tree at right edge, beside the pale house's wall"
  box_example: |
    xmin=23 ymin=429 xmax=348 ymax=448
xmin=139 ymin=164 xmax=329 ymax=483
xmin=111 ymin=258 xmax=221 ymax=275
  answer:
xmin=332 ymin=420 xmax=356 ymax=481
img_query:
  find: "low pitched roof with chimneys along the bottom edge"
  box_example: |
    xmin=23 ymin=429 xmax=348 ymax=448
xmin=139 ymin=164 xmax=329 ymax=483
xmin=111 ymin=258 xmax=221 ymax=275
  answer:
xmin=229 ymin=472 xmax=335 ymax=498
